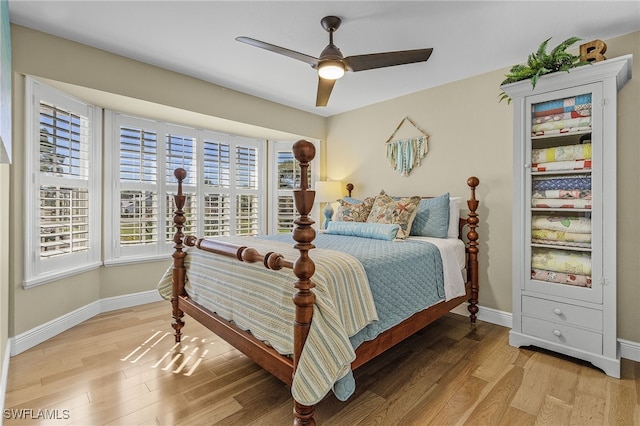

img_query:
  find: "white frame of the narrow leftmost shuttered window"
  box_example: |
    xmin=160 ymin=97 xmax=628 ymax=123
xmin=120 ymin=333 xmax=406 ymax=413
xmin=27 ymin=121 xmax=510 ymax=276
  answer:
xmin=22 ymin=76 xmax=102 ymax=288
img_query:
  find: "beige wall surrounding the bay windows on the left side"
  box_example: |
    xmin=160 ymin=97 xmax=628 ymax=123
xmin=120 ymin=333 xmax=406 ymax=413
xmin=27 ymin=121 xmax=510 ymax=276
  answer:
xmin=9 ymin=25 xmax=325 ymax=341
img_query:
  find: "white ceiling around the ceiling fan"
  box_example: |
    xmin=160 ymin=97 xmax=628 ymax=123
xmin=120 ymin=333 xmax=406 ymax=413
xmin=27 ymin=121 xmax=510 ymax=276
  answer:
xmin=9 ymin=0 xmax=640 ymax=116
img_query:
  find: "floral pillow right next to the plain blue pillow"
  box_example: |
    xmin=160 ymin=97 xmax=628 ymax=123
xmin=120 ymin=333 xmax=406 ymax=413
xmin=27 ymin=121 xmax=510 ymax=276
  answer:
xmin=367 ymin=190 xmax=420 ymax=238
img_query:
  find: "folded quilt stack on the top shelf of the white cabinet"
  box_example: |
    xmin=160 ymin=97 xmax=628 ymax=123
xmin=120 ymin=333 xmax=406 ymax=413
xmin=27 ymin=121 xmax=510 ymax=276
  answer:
xmin=531 ymin=93 xmax=591 ymax=136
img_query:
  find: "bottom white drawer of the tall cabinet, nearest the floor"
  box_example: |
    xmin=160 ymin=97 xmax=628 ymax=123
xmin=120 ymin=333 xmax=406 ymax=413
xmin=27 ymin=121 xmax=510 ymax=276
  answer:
xmin=522 ymin=316 xmax=602 ymax=354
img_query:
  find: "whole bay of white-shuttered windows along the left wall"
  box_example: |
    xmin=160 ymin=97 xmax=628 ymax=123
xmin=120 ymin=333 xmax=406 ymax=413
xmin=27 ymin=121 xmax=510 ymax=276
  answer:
xmin=24 ymin=81 xmax=318 ymax=278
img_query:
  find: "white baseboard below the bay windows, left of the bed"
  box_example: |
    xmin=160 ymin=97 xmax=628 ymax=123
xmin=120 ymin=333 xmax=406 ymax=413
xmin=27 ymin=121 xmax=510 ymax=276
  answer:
xmin=9 ymin=290 xmax=162 ymax=356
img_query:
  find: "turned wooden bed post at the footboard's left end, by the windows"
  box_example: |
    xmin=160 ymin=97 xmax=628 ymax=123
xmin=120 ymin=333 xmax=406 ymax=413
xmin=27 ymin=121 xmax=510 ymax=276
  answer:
xmin=171 ymin=169 xmax=187 ymax=342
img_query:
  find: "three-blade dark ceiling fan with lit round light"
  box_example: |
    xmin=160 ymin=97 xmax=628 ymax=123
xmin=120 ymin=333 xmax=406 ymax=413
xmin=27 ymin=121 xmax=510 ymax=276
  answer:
xmin=236 ymin=16 xmax=433 ymax=107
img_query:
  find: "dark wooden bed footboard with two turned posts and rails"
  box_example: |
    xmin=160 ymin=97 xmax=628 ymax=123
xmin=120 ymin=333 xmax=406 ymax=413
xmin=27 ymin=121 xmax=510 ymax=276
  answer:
xmin=171 ymin=140 xmax=316 ymax=425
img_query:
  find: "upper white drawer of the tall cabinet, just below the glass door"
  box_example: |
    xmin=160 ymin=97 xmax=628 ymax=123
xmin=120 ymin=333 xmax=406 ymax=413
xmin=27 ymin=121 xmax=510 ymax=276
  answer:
xmin=522 ymin=296 xmax=602 ymax=331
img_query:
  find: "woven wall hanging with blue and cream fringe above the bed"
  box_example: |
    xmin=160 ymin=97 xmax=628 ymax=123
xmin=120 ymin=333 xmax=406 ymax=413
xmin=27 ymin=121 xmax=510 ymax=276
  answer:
xmin=386 ymin=117 xmax=429 ymax=176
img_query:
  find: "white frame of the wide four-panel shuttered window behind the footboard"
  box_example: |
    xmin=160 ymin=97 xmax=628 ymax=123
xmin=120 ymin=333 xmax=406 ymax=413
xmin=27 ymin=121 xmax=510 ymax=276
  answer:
xmin=104 ymin=110 xmax=268 ymax=265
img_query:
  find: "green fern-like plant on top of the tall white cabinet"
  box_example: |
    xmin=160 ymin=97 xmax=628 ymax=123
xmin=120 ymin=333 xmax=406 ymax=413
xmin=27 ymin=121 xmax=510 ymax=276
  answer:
xmin=499 ymin=37 xmax=589 ymax=102
